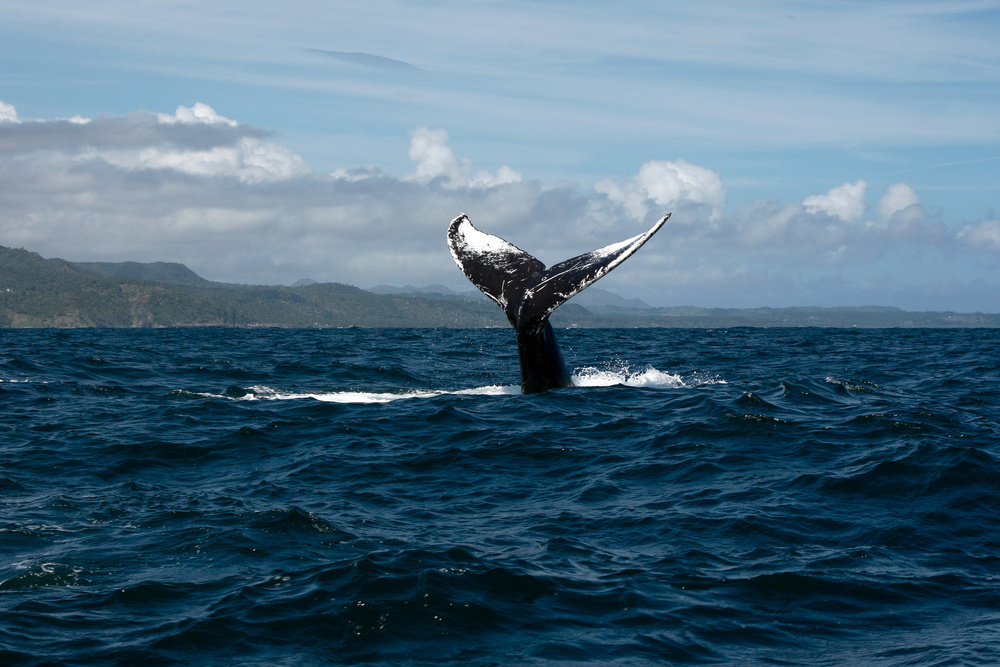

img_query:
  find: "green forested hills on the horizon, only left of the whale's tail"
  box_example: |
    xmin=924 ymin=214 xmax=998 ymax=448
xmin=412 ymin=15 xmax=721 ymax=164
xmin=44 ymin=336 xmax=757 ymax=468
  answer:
xmin=0 ymin=246 xmax=505 ymax=327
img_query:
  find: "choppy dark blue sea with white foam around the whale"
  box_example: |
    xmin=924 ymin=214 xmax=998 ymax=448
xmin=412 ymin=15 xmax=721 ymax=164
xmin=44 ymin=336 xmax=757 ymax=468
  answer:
xmin=0 ymin=329 xmax=1000 ymax=666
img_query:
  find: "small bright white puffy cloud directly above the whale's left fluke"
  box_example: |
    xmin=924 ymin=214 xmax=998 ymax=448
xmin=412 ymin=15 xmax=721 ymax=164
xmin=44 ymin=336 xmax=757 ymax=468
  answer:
xmin=409 ymin=127 xmax=523 ymax=188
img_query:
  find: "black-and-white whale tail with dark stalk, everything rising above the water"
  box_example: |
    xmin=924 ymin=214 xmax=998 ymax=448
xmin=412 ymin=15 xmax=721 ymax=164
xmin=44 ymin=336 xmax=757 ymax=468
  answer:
xmin=448 ymin=213 xmax=670 ymax=394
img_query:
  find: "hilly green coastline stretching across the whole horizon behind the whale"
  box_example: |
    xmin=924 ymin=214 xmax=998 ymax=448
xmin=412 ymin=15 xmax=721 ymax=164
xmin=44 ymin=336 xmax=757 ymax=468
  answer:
xmin=0 ymin=246 xmax=1000 ymax=329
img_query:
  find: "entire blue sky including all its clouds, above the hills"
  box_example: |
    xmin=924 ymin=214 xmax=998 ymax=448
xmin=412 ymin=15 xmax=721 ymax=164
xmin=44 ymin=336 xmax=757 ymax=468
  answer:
xmin=0 ymin=0 xmax=1000 ymax=313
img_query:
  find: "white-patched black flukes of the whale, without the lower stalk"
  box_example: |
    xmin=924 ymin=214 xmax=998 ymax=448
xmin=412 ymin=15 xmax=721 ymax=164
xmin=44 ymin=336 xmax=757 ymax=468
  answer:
xmin=448 ymin=213 xmax=670 ymax=336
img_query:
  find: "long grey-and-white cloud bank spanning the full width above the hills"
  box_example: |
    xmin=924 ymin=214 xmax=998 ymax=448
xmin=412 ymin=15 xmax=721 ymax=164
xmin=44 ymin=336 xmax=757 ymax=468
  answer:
xmin=0 ymin=102 xmax=1000 ymax=311
